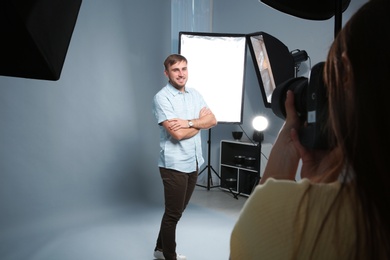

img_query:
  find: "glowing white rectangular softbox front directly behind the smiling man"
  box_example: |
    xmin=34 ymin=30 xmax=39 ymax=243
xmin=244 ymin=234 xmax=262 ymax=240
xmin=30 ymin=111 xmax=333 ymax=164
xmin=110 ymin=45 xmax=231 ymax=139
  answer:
xmin=179 ymin=32 xmax=246 ymax=124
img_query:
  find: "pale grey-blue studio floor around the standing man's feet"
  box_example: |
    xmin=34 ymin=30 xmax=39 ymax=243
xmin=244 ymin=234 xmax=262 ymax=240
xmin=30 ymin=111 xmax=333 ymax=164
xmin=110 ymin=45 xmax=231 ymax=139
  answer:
xmin=0 ymin=187 xmax=247 ymax=260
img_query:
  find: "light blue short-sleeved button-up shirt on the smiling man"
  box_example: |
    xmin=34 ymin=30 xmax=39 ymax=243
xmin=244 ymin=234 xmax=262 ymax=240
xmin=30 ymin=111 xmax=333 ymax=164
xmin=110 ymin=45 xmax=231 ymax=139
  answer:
xmin=153 ymin=83 xmax=207 ymax=173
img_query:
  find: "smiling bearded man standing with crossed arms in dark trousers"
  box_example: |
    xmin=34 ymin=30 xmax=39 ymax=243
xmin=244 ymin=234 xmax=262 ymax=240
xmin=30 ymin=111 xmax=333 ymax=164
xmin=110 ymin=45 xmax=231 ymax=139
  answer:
xmin=153 ymin=54 xmax=217 ymax=260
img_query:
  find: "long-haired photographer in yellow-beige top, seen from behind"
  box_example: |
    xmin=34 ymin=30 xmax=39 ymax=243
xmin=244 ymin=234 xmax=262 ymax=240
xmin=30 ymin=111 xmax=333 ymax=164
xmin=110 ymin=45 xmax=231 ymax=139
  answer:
xmin=230 ymin=0 xmax=390 ymax=260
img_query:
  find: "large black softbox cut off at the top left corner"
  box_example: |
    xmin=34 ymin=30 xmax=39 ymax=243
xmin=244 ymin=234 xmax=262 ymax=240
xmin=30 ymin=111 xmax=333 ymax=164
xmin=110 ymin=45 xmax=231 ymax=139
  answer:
xmin=0 ymin=0 xmax=82 ymax=80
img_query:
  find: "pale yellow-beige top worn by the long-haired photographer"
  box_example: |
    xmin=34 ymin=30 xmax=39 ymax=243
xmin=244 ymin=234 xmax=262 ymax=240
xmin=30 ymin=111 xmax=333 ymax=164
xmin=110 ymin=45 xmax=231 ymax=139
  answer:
xmin=230 ymin=179 xmax=356 ymax=260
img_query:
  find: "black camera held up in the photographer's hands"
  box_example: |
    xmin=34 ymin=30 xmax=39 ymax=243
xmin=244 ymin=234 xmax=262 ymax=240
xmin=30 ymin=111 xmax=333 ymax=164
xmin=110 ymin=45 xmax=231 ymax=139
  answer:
xmin=271 ymin=62 xmax=330 ymax=149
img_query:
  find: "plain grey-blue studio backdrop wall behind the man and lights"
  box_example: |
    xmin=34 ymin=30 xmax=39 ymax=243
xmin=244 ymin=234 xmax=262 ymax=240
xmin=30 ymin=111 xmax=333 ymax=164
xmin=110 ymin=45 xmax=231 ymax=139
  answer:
xmin=0 ymin=0 xmax=366 ymax=254
